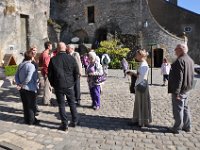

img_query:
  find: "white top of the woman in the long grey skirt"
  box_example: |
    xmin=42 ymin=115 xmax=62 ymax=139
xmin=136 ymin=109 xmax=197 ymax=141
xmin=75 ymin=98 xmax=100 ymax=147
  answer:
xmin=135 ymin=61 xmax=149 ymax=86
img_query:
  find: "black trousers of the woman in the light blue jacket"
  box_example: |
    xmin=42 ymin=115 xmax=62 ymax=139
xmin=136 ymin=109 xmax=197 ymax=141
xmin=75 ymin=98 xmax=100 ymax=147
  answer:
xmin=20 ymin=89 xmax=36 ymax=124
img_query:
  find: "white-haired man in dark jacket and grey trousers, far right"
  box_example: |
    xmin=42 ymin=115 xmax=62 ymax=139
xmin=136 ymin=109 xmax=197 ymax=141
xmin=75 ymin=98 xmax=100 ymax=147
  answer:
xmin=168 ymin=44 xmax=194 ymax=134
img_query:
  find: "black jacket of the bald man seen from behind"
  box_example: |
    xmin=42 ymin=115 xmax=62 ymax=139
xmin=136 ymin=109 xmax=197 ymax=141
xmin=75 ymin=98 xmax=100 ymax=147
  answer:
xmin=48 ymin=52 xmax=79 ymax=91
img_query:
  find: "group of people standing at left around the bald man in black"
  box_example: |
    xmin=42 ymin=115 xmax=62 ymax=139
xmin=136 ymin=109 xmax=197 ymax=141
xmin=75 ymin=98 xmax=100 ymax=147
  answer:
xmin=15 ymin=42 xmax=110 ymax=131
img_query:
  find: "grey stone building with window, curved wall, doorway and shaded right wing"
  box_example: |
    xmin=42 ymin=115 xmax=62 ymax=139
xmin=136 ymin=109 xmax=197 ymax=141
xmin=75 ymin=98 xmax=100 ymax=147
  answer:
xmin=50 ymin=0 xmax=200 ymax=67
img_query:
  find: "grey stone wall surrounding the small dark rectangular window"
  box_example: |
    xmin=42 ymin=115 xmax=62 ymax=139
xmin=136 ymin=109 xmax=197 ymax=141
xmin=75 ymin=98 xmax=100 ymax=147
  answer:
xmin=51 ymin=0 xmax=143 ymax=42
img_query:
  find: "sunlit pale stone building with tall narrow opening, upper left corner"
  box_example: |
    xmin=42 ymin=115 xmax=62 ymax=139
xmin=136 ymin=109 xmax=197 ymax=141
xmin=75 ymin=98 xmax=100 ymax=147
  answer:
xmin=0 ymin=0 xmax=50 ymax=63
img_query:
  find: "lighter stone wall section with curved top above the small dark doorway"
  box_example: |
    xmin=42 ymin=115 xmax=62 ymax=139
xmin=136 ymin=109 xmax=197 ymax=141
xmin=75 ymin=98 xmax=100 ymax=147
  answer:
xmin=142 ymin=0 xmax=184 ymax=60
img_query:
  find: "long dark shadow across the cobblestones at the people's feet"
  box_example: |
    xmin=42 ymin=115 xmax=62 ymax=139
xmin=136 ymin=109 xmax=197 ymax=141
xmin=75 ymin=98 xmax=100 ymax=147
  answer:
xmin=0 ymin=103 xmax=168 ymax=133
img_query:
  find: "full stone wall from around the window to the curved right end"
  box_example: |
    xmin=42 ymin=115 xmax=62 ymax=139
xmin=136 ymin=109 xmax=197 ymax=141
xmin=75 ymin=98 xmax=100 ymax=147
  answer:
xmin=51 ymin=0 xmax=183 ymax=62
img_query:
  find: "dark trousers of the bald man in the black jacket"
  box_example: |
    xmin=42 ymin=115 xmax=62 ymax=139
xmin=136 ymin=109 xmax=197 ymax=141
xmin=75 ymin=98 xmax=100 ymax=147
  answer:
xmin=55 ymin=86 xmax=78 ymax=125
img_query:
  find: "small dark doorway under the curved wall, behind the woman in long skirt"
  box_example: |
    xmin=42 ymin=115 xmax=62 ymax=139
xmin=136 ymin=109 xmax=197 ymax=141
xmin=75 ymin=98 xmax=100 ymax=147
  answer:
xmin=153 ymin=48 xmax=164 ymax=67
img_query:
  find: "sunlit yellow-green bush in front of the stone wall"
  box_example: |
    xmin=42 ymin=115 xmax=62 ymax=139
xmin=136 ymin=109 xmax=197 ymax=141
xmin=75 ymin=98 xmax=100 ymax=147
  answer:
xmin=96 ymin=40 xmax=130 ymax=69
